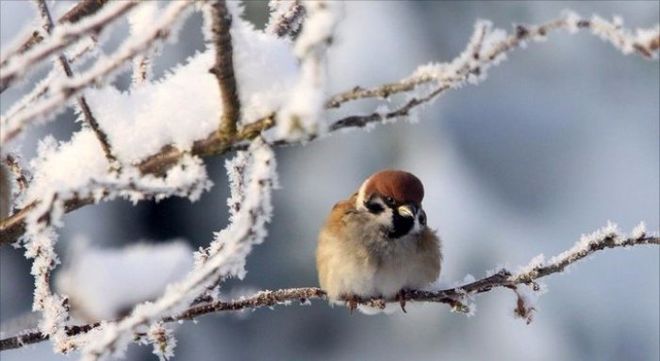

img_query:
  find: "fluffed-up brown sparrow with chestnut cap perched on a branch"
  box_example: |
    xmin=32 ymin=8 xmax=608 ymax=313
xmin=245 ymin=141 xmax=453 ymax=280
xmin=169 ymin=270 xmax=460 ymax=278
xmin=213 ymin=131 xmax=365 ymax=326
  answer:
xmin=316 ymin=169 xmax=442 ymax=313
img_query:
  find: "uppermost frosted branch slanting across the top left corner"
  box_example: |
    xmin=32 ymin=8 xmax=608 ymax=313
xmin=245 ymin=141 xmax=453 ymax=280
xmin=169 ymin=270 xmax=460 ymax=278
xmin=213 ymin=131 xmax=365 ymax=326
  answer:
xmin=0 ymin=1 xmax=137 ymax=91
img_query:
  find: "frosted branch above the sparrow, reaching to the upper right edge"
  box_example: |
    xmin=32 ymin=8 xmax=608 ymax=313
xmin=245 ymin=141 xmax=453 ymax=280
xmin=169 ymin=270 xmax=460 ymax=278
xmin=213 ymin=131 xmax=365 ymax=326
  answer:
xmin=326 ymin=11 xmax=660 ymax=128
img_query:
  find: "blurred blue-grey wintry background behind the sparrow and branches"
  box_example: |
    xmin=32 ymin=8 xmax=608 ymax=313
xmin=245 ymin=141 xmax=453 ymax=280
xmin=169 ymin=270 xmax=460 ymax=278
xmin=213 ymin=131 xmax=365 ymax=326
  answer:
xmin=0 ymin=0 xmax=660 ymax=361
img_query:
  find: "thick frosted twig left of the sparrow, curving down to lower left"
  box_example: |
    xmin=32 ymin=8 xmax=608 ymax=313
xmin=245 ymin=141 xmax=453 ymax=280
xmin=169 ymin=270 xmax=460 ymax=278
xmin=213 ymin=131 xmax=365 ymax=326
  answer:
xmin=82 ymin=138 xmax=277 ymax=361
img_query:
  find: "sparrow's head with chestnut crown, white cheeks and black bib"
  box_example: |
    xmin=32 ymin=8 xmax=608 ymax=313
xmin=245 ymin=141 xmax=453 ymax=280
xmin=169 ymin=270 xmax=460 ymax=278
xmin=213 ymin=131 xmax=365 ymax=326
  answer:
xmin=355 ymin=169 xmax=426 ymax=239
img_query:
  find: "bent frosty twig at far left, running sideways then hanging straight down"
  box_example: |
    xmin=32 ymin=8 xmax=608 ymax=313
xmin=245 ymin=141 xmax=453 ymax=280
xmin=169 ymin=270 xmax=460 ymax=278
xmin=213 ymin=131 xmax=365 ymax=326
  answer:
xmin=2 ymin=157 xmax=210 ymax=353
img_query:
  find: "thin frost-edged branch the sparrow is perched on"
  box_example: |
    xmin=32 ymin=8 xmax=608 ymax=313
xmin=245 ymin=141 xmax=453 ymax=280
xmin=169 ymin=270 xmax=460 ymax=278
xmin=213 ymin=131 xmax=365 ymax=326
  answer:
xmin=0 ymin=231 xmax=660 ymax=351
